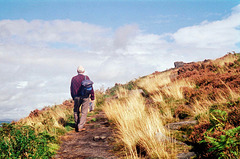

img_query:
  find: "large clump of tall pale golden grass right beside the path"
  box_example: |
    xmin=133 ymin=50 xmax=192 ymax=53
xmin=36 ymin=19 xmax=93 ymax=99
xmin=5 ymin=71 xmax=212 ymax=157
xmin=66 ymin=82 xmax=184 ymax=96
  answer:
xmin=103 ymin=89 xmax=175 ymax=158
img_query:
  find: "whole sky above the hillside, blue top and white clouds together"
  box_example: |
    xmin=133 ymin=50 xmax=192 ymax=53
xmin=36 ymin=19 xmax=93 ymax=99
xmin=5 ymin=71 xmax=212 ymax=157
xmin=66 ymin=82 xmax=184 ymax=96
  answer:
xmin=0 ymin=0 xmax=240 ymax=120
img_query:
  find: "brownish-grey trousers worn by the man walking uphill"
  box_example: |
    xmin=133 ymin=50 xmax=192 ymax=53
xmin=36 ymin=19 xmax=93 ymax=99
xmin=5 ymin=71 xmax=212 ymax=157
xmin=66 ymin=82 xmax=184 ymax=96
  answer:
xmin=73 ymin=97 xmax=90 ymax=129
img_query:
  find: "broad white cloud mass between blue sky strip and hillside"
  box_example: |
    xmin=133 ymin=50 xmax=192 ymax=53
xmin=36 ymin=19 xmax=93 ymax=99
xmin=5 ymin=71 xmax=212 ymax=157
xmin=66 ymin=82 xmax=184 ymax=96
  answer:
xmin=0 ymin=5 xmax=240 ymax=120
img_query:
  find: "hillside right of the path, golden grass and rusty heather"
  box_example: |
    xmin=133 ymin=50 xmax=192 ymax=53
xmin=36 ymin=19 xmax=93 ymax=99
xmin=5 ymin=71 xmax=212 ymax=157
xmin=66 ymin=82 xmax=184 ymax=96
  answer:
xmin=103 ymin=53 xmax=240 ymax=158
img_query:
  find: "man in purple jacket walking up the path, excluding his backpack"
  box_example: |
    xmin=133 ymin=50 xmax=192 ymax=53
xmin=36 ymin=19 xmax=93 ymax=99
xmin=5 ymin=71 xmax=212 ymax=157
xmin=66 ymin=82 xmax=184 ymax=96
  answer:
xmin=70 ymin=66 xmax=94 ymax=132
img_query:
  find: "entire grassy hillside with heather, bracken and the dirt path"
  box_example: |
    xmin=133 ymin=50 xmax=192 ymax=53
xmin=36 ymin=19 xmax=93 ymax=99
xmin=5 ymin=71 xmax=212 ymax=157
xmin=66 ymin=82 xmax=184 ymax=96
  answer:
xmin=0 ymin=53 xmax=240 ymax=158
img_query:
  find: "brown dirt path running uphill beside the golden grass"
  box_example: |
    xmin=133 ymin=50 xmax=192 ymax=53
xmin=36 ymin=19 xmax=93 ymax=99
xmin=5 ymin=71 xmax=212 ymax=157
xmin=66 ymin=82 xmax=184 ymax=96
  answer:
xmin=54 ymin=112 xmax=117 ymax=159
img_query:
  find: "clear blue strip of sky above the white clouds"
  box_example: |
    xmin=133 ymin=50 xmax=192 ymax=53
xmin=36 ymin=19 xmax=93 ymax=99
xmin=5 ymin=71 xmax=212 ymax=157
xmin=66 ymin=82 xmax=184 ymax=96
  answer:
xmin=0 ymin=0 xmax=239 ymax=34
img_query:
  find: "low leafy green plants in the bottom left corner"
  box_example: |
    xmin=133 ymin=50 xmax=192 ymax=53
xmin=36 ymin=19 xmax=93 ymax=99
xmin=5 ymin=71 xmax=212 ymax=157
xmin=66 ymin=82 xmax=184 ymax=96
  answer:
xmin=0 ymin=124 xmax=58 ymax=159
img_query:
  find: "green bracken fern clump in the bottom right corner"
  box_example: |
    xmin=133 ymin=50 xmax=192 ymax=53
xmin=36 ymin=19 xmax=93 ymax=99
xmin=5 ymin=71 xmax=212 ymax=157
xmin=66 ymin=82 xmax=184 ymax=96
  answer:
xmin=200 ymin=110 xmax=240 ymax=158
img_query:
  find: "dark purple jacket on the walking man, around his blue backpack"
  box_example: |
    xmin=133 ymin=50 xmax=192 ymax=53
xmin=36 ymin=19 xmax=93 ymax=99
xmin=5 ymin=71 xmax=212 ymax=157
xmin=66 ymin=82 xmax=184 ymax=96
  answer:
xmin=70 ymin=74 xmax=94 ymax=100
